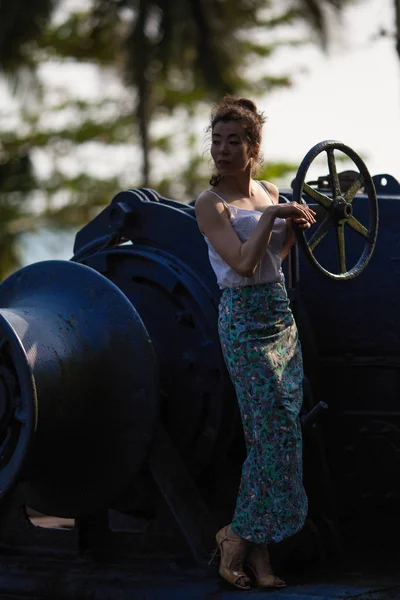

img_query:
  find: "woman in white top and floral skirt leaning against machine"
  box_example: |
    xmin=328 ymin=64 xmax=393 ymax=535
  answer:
xmin=196 ymin=97 xmax=315 ymax=589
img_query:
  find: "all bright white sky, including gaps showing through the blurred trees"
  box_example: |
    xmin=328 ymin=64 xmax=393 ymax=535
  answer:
xmin=0 ymin=0 xmax=400 ymax=263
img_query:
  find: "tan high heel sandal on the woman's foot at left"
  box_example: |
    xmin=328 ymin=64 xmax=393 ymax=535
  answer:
xmin=208 ymin=525 xmax=251 ymax=590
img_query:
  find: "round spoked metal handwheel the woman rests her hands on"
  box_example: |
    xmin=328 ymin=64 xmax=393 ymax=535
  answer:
xmin=293 ymin=140 xmax=378 ymax=281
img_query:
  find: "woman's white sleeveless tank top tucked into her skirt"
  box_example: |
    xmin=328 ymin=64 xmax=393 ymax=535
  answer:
xmin=204 ymin=183 xmax=286 ymax=289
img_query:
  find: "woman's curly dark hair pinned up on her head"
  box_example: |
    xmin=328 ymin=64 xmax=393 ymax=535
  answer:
xmin=208 ymin=96 xmax=266 ymax=186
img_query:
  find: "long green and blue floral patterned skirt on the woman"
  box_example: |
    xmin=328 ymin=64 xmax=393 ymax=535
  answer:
xmin=218 ymin=283 xmax=307 ymax=544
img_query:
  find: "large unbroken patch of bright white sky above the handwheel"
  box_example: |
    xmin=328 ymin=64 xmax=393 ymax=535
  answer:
xmin=259 ymin=0 xmax=400 ymax=179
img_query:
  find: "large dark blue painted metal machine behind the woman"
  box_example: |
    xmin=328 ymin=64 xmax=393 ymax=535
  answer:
xmin=0 ymin=170 xmax=400 ymax=600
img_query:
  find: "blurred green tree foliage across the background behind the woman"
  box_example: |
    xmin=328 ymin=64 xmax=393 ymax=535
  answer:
xmin=0 ymin=0 xmax=351 ymax=277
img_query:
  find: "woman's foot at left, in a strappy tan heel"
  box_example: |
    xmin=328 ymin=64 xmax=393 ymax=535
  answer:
xmin=215 ymin=525 xmax=251 ymax=590
